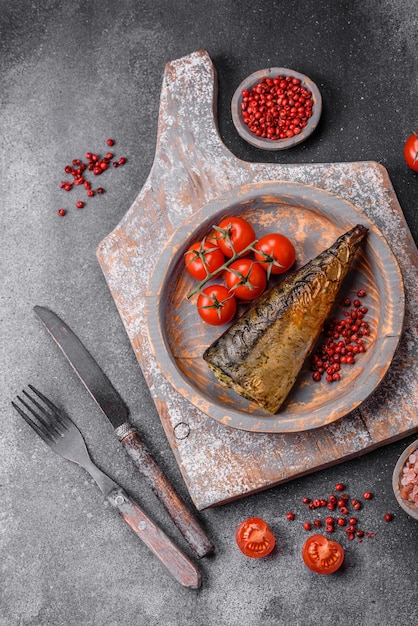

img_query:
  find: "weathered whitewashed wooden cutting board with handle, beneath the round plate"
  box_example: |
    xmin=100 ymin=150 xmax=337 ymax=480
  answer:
xmin=97 ymin=51 xmax=418 ymax=509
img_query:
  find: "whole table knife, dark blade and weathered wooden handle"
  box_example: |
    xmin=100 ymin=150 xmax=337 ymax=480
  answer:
xmin=33 ymin=306 xmax=214 ymax=558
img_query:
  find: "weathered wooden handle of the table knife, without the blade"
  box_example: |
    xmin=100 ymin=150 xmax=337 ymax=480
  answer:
xmin=116 ymin=425 xmax=214 ymax=558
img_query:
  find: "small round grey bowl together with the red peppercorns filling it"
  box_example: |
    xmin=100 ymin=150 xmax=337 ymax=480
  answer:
xmin=231 ymin=67 xmax=322 ymax=150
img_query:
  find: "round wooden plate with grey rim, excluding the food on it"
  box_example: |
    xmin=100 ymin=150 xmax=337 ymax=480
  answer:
xmin=145 ymin=181 xmax=404 ymax=433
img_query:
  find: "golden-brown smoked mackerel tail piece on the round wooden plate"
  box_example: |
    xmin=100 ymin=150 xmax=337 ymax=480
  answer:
xmin=203 ymin=224 xmax=368 ymax=414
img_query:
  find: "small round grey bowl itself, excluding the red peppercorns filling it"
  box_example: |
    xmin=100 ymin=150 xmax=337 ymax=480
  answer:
xmin=231 ymin=67 xmax=322 ymax=150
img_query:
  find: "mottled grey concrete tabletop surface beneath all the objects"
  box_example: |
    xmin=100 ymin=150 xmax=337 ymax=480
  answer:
xmin=0 ymin=0 xmax=418 ymax=626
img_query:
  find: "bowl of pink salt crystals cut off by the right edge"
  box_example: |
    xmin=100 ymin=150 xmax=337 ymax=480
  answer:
xmin=392 ymin=439 xmax=418 ymax=520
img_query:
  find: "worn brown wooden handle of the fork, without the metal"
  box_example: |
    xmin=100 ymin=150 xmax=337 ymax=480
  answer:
xmin=107 ymin=487 xmax=201 ymax=589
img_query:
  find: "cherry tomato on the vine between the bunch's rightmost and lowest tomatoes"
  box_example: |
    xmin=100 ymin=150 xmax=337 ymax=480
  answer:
xmin=225 ymin=259 xmax=267 ymax=300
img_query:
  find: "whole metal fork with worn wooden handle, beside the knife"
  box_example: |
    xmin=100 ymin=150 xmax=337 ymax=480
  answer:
xmin=12 ymin=385 xmax=201 ymax=589
